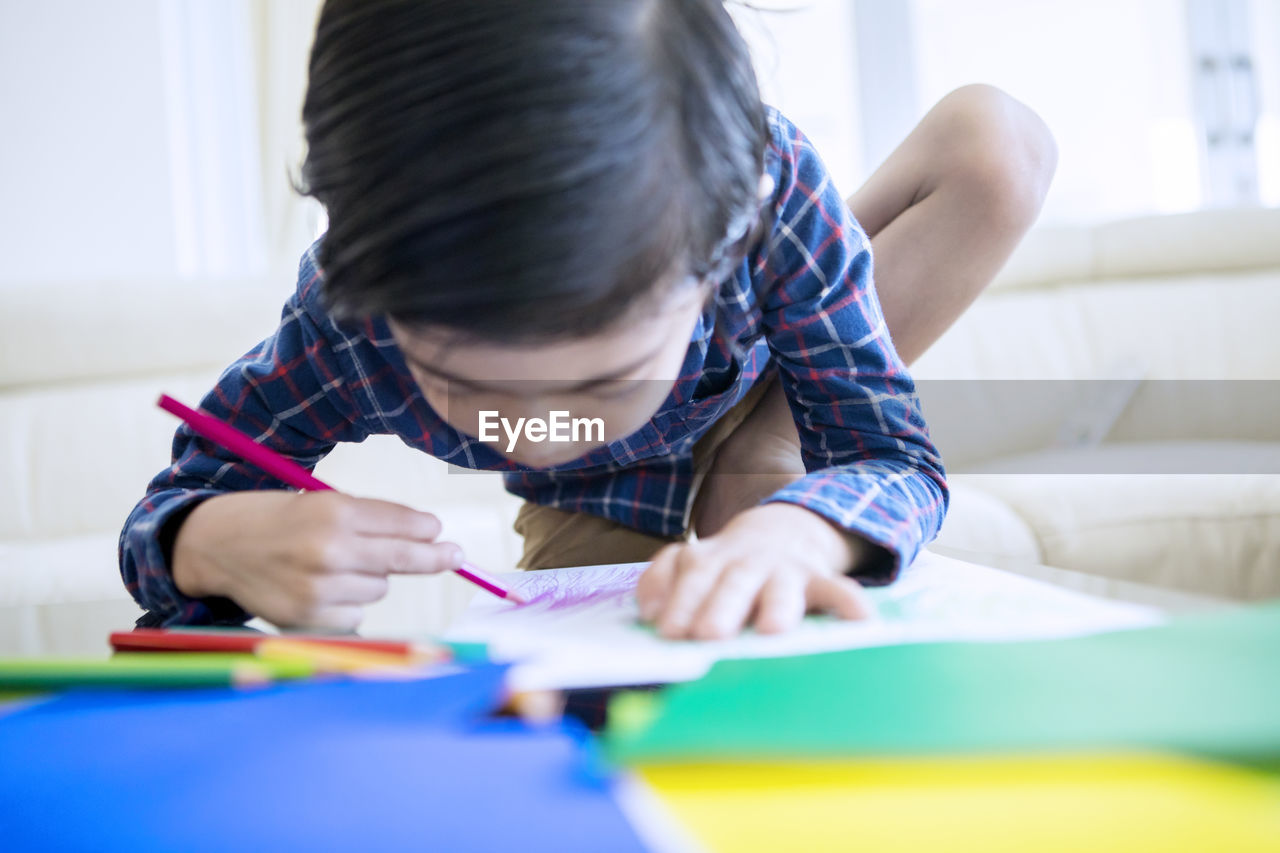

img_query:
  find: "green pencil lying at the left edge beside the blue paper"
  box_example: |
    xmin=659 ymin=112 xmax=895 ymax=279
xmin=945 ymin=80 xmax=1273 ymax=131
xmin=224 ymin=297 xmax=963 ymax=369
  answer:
xmin=0 ymin=653 xmax=315 ymax=690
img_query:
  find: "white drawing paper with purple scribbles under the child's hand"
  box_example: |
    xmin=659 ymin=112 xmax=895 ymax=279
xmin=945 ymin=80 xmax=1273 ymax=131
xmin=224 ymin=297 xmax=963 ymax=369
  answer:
xmin=447 ymin=552 xmax=1162 ymax=689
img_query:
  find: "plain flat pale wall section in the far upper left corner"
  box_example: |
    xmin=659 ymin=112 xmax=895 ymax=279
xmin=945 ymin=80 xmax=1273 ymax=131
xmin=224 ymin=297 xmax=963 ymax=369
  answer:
xmin=0 ymin=0 xmax=175 ymax=282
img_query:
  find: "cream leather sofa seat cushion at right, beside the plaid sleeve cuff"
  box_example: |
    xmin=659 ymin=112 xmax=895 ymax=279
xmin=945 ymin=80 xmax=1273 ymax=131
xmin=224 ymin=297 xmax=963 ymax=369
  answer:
xmin=960 ymin=444 xmax=1280 ymax=599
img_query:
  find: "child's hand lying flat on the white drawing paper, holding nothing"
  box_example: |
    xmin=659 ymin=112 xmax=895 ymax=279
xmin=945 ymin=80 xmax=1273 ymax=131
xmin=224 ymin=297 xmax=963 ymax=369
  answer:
xmin=636 ymin=503 xmax=872 ymax=639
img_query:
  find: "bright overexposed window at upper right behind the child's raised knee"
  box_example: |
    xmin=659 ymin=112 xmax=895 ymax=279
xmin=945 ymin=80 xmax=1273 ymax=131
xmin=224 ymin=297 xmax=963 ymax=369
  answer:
xmin=737 ymin=0 xmax=1280 ymax=223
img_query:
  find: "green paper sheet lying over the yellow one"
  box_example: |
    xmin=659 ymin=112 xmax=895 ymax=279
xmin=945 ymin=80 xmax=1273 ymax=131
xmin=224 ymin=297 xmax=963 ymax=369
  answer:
xmin=607 ymin=602 xmax=1280 ymax=766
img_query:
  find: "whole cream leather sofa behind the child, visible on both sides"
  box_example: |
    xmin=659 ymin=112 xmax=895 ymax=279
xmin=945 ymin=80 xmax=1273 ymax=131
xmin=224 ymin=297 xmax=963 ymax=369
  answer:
xmin=0 ymin=210 xmax=1280 ymax=654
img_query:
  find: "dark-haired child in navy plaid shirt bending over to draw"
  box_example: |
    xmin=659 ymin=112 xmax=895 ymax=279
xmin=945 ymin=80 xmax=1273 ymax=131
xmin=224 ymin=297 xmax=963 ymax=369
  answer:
xmin=120 ymin=0 xmax=1052 ymax=638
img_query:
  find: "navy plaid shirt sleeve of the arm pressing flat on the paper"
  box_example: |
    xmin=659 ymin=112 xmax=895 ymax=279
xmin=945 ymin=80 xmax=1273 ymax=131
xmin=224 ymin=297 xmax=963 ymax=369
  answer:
xmin=756 ymin=111 xmax=947 ymax=584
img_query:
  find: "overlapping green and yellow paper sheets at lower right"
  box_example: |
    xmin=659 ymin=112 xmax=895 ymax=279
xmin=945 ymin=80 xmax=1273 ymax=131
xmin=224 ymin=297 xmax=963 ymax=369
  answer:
xmin=607 ymin=605 xmax=1280 ymax=853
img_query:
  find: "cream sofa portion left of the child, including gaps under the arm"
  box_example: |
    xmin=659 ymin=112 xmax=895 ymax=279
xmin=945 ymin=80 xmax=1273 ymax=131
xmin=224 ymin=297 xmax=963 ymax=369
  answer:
xmin=0 ymin=272 xmax=518 ymax=654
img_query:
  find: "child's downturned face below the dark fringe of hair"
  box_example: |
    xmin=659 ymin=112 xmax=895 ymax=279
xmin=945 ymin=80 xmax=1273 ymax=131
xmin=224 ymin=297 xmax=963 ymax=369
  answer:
xmin=390 ymin=287 xmax=707 ymax=467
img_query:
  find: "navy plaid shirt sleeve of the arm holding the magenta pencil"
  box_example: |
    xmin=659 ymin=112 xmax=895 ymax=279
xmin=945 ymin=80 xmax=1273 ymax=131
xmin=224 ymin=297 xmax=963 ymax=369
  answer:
xmin=119 ymin=275 xmax=370 ymax=626
